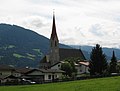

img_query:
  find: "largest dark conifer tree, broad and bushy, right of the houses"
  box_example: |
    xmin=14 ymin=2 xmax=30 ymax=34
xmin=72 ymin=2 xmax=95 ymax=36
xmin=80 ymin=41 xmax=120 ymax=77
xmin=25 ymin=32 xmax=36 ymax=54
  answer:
xmin=89 ymin=44 xmax=107 ymax=75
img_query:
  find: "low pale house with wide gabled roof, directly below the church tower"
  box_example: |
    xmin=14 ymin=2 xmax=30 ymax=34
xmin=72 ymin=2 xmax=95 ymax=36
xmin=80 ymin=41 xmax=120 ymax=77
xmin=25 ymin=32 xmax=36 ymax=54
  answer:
xmin=26 ymin=69 xmax=64 ymax=82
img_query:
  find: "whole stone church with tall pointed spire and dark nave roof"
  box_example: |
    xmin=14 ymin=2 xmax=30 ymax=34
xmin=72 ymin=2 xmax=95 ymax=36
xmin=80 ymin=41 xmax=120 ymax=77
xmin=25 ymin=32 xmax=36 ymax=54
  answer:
xmin=40 ymin=13 xmax=86 ymax=69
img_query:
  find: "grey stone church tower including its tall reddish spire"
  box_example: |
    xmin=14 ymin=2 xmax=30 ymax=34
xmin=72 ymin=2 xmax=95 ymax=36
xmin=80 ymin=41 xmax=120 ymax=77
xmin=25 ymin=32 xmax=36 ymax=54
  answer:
xmin=50 ymin=12 xmax=59 ymax=65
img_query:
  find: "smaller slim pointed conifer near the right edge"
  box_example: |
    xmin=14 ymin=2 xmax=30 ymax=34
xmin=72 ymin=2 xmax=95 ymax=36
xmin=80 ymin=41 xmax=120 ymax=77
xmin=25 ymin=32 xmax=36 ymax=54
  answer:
xmin=110 ymin=51 xmax=117 ymax=73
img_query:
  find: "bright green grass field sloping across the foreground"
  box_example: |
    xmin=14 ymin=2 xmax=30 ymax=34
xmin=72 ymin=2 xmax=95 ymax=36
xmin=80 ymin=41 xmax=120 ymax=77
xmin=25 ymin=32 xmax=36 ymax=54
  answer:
xmin=0 ymin=76 xmax=120 ymax=91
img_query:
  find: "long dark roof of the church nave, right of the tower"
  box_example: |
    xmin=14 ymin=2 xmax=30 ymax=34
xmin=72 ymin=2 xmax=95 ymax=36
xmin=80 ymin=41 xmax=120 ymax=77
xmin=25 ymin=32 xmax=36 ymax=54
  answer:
xmin=59 ymin=48 xmax=85 ymax=61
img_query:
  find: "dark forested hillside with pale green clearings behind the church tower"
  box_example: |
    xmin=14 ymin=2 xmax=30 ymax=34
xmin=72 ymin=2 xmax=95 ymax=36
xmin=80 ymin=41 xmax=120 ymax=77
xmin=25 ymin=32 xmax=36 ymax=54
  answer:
xmin=0 ymin=24 xmax=71 ymax=67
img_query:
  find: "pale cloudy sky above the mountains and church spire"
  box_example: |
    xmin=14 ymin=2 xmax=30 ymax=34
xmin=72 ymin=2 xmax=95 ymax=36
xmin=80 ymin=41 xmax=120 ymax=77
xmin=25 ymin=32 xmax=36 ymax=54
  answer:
xmin=0 ymin=0 xmax=120 ymax=48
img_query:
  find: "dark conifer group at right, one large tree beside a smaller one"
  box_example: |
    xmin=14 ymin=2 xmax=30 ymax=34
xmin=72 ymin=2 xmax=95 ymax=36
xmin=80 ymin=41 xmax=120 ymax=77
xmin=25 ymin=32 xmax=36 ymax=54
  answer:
xmin=89 ymin=44 xmax=120 ymax=76
